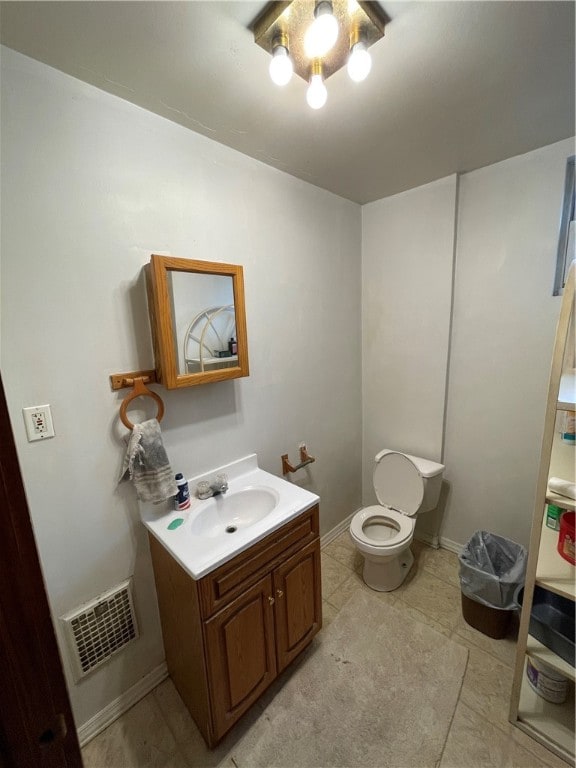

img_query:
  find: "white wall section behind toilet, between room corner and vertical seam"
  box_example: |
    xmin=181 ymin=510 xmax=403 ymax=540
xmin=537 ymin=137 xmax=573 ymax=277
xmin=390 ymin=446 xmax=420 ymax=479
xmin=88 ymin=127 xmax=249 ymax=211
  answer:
xmin=362 ymin=176 xmax=457 ymax=520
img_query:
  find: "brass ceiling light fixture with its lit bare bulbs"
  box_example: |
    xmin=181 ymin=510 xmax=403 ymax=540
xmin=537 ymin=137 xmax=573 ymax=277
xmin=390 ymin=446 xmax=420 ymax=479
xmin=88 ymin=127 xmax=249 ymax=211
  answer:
xmin=252 ymin=0 xmax=389 ymax=109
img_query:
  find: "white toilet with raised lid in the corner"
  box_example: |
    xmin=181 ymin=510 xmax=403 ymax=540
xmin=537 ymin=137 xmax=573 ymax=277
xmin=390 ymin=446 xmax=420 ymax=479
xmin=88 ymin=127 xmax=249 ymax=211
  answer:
xmin=350 ymin=450 xmax=444 ymax=592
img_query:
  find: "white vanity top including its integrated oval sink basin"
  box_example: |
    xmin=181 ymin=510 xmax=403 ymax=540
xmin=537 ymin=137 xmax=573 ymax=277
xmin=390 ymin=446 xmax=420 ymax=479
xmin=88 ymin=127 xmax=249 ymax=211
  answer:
xmin=140 ymin=454 xmax=319 ymax=579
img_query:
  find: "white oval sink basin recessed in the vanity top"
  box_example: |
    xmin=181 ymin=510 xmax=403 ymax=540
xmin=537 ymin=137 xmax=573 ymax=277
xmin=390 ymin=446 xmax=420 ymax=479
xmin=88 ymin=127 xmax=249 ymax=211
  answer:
xmin=190 ymin=487 xmax=280 ymax=538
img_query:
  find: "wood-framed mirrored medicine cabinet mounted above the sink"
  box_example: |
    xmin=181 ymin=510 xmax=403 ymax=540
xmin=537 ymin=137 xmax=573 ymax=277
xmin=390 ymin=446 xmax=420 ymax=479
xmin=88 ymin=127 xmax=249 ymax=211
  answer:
xmin=146 ymin=254 xmax=249 ymax=389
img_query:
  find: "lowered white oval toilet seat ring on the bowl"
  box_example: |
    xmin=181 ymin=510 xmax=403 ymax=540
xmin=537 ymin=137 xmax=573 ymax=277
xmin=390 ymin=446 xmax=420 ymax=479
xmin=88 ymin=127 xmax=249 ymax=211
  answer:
xmin=350 ymin=504 xmax=416 ymax=557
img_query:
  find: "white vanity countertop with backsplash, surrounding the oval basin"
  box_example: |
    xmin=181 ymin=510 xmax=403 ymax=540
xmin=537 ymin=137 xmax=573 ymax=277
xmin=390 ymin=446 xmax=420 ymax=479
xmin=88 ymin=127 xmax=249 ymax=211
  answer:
xmin=140 ymin=454 xmax=319 ymax=579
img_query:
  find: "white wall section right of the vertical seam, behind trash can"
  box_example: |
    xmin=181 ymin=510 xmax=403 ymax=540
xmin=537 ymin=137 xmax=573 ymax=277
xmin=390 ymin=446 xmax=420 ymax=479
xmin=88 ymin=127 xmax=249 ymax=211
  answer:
xmin=442 ymin=140 xmax=574 ymax=545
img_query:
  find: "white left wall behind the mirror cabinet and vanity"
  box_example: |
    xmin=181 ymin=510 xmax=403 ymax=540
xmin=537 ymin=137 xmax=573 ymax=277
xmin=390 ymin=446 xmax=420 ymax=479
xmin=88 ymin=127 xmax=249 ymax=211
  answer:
xmin=1 ymin=49 xmax=361 ymax=725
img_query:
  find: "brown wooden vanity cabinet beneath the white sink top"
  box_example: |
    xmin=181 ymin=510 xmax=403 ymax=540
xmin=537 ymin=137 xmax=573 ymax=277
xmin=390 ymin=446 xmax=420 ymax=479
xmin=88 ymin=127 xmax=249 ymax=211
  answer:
xmin=150 ymin=505 xmax=322 ymax=747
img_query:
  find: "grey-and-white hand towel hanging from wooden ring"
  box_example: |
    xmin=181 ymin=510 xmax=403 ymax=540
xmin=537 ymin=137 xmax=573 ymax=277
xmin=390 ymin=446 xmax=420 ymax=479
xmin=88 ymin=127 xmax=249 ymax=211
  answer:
xmin=120 ymin=419 xmax=178 ymax=504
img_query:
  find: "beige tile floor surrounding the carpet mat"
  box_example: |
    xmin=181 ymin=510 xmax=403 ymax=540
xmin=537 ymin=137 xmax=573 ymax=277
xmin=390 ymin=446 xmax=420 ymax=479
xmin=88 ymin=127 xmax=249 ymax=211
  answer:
xmin=82 ymin=531 xmax=566 ymax=768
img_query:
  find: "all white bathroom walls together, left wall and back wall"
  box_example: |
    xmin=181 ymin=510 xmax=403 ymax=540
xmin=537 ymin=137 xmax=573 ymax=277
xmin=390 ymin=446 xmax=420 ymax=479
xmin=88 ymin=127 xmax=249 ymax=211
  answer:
xmin=0 ymin=42 xmax=574 ymax=736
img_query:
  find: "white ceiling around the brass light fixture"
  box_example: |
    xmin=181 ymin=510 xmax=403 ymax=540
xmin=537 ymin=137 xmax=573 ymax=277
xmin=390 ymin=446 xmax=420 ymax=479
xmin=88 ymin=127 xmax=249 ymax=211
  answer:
xmin=0 ymin=0 xmax=575 ymax=203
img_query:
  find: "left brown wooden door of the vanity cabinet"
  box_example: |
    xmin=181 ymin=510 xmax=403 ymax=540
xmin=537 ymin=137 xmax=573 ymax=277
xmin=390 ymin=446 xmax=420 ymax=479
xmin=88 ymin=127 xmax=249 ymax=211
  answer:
xmin=204 ymin=576 xmax=276 ymax=741
